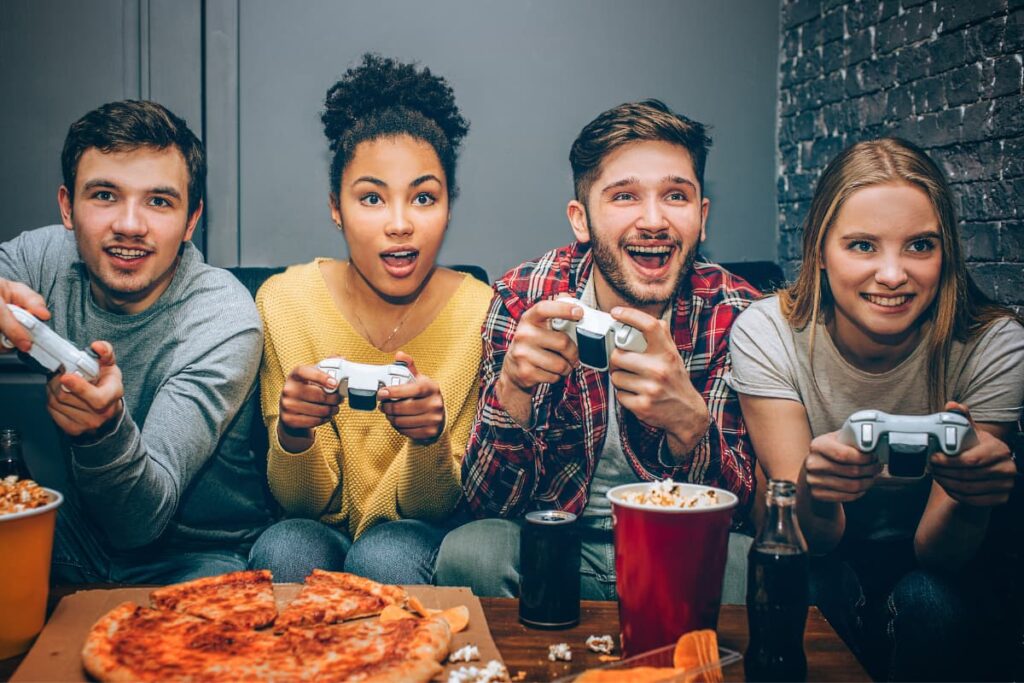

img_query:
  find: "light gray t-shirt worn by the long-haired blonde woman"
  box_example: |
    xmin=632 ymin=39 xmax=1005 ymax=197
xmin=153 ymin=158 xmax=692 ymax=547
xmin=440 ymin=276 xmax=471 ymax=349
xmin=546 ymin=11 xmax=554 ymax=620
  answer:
xmin=726 ymin=296 xmax=1024 ymax=540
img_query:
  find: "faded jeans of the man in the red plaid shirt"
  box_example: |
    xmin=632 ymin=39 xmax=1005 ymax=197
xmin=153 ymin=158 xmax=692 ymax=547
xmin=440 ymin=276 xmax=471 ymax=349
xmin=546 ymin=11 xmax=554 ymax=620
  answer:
xmin=434 ymin=517 xmax=752 ymax=604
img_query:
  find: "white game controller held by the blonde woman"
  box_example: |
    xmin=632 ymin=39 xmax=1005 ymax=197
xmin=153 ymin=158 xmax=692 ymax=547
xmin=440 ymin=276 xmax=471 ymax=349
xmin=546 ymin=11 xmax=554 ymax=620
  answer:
xmin=839 ymin=411 xmax=978 ymax=479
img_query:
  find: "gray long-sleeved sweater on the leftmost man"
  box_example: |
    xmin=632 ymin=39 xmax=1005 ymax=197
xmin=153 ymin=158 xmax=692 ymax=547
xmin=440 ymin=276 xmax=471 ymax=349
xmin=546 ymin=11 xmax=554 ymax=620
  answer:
xmin=0 ymin=225 xmax=269 ymax=554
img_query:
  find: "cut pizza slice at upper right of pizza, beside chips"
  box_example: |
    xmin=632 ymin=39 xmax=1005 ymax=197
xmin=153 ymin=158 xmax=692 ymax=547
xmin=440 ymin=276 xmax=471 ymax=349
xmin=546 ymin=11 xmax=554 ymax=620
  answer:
xmin=275 ymin=569 xmax=409 ymax=632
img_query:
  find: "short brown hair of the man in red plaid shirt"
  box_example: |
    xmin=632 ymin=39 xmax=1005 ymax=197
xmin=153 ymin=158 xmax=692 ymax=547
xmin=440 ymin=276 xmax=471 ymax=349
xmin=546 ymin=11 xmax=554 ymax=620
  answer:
xmin=569 ymin=99 xmax=711 ymax=203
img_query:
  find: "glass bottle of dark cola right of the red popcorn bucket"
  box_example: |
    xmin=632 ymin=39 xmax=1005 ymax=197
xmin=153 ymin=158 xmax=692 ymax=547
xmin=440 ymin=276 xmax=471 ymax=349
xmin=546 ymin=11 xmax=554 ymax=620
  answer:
xmin=743 ymin=479 xmax=810 ymax=681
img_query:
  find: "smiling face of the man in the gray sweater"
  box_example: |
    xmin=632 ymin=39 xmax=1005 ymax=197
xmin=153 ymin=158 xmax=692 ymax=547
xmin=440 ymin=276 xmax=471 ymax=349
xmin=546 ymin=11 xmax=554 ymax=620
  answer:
xmin=57 ymin=146 xmax=203 ymax=313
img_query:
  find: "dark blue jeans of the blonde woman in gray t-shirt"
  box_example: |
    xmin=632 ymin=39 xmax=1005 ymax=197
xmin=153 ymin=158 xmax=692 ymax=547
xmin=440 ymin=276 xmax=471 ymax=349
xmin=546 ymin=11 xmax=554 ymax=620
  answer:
xmin=811 ymin=540 xmax=1009 ymax=681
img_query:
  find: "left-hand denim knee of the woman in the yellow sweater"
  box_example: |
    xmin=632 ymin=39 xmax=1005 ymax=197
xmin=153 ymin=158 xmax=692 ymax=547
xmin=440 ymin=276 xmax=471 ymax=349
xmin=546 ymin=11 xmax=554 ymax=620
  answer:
xmin=249 ymin=519 xmax=352 ymax=584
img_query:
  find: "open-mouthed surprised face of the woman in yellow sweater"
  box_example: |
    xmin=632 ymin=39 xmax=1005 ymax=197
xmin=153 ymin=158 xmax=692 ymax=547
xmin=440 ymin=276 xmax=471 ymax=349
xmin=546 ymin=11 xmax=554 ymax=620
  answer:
xmin=331 ymin=135 xmax=449 ymax=301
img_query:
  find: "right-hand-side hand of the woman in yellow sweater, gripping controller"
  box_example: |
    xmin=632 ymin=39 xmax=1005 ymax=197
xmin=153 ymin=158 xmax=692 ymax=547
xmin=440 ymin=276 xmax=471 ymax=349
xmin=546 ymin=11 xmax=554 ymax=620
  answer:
xmin=377 ymin=351 xmax=444 ymax=442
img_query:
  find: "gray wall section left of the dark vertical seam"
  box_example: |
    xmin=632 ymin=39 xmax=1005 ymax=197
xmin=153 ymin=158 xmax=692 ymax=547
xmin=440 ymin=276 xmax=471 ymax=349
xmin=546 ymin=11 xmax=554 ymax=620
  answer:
xmin=0 ymin=0 xmax=203 ymax=244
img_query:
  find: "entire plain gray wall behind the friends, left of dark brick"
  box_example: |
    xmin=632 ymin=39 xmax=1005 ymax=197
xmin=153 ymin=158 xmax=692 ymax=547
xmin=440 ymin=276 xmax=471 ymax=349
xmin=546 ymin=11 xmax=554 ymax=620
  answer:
xmin=0 ymin=0 xmax=778 ymax=276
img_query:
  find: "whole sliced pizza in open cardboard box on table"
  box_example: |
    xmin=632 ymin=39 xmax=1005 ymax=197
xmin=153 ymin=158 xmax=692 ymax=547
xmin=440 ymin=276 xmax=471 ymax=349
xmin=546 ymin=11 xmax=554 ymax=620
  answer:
xmin=82 ymin=571 xmax=452 ymax=683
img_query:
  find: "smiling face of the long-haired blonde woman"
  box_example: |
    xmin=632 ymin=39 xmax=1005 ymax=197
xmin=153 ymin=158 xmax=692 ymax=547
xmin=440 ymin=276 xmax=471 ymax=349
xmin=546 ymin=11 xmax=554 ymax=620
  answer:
xmin=821 ymin=182 xmax=942 ymax=355
